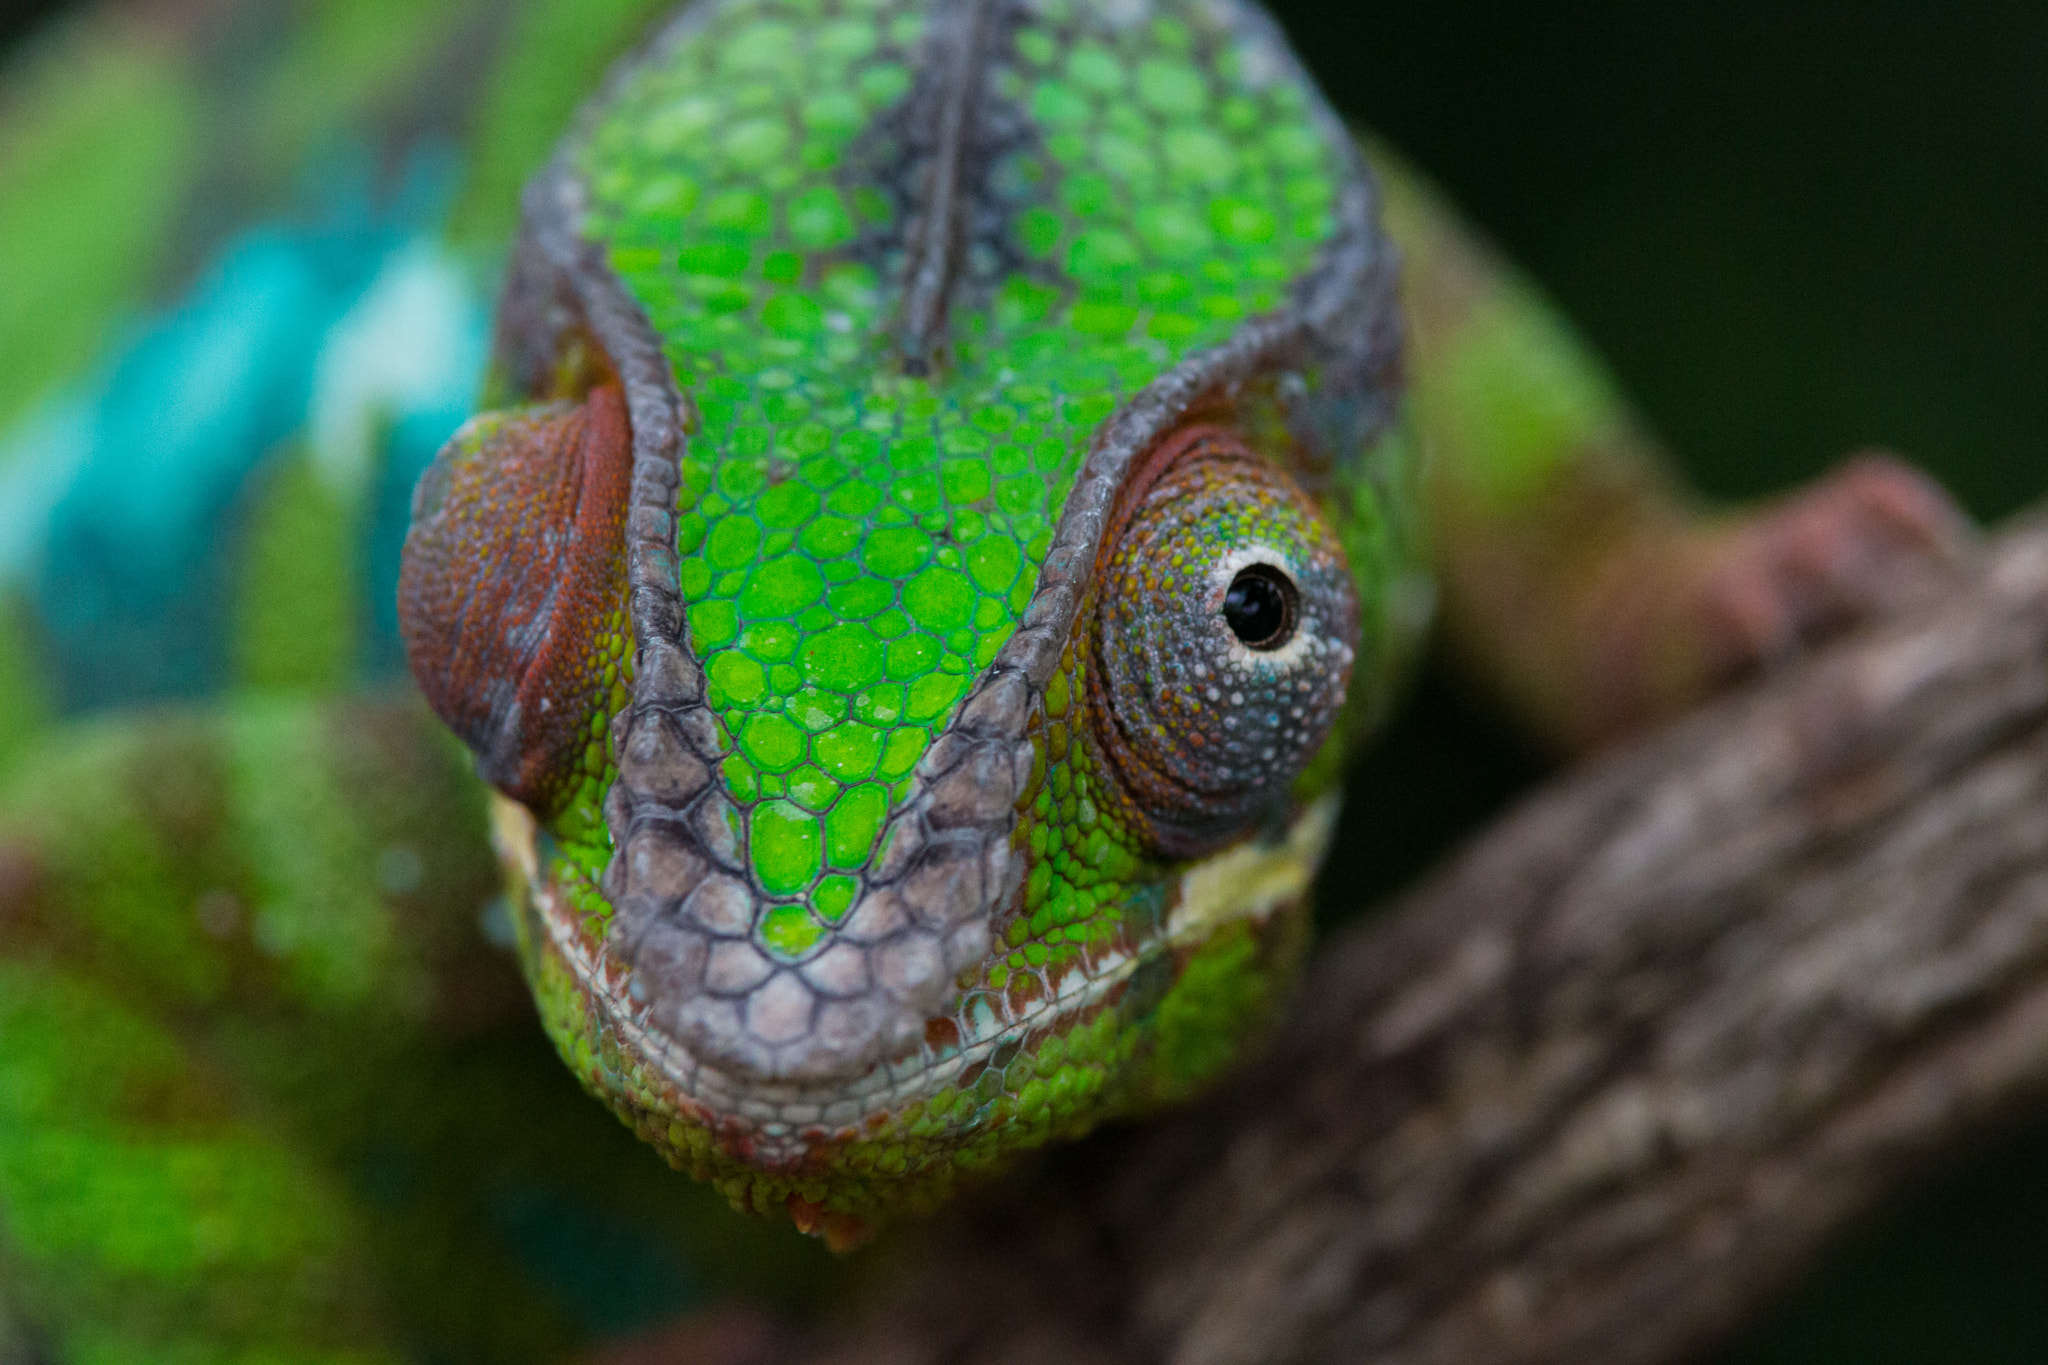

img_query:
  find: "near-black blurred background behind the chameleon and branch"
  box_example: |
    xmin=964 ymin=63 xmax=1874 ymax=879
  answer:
xmin=12 ymin=0 xmax=2048 ymax=1365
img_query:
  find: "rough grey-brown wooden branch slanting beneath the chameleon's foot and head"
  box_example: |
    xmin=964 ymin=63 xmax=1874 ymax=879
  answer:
xmin=797 ymin=520 xmax=2048 ymax=1365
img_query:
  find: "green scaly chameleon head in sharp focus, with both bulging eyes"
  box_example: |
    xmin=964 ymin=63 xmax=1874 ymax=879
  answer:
xmin=401 ymin=0 xmax=1427 ymax=1234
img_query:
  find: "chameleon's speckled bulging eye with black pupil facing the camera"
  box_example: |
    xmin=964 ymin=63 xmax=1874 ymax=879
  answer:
xmin=1087 ymin=426 xmax=1358 ymax=857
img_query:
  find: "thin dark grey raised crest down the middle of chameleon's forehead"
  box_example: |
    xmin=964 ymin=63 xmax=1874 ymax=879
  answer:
xmin=901 ymin=0 xmax=995 ymax=375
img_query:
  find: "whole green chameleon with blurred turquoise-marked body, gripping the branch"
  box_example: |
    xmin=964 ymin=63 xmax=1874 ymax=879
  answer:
xmin=0 ymin=0 xmax=1966 ymax=1359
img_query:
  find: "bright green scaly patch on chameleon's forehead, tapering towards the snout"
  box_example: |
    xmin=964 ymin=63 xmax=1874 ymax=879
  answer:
xmin=582 ymin=0 xmax=1346 ymax=956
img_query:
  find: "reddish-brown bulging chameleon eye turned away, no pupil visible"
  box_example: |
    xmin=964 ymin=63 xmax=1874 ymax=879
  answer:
xmin=399 ymin=385 xmax=633 ymax=819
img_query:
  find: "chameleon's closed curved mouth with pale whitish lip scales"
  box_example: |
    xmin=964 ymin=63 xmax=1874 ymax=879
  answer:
xmin=492 ymin=792 xmax=1339 ymax=1169
